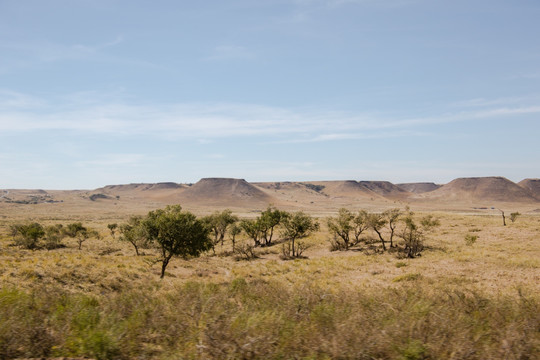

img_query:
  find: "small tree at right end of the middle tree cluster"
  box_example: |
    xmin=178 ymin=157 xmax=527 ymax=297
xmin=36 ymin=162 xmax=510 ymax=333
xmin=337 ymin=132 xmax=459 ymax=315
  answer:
xmin=282 ymin=211 xmax=319 ymax=257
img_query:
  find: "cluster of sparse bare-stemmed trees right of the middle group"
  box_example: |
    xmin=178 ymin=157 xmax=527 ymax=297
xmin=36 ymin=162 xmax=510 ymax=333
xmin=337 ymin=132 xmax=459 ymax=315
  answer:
xmin=327 ymin=208 xmax=439 ymax=258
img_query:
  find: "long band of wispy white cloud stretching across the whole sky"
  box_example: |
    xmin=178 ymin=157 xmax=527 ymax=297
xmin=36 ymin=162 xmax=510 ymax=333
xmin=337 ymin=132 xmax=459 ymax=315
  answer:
xmin=0 ymin=91 xmax=540 ymax=142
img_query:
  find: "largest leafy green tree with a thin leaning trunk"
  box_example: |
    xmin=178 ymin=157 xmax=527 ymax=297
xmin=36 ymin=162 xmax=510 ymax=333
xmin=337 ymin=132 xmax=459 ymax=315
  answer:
xmin=143 ymin=205 xmax=212 ymax=278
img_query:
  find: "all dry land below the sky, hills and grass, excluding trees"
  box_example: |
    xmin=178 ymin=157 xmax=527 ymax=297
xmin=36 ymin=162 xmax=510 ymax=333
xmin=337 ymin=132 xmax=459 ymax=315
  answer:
xmin=0 ymin=177 xmax=540 ymax=359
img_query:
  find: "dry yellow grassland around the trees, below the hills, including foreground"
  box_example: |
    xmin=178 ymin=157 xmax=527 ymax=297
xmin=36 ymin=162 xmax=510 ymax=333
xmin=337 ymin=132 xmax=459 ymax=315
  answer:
xmin=0 ymin=205 xmax=540 ymax=359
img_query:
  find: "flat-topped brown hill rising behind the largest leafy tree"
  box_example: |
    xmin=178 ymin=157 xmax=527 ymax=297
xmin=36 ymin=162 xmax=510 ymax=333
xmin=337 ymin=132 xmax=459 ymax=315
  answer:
xmin=180 ymin=178 xmax=273 ymax=207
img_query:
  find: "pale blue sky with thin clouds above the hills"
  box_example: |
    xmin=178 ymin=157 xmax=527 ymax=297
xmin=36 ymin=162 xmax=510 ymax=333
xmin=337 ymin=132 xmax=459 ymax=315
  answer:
xmin=0 ymin=0 xmax=540 ymax=189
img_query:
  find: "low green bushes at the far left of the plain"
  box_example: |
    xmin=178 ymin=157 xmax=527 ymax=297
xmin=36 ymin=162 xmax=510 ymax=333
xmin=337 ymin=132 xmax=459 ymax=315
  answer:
xmin=9 ymin=222 xmax=99 ymax=250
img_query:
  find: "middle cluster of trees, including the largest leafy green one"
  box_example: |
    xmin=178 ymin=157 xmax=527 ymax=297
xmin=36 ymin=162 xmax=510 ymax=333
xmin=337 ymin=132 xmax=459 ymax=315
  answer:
xmin=114 ymin=205 xmax=319 ymax=277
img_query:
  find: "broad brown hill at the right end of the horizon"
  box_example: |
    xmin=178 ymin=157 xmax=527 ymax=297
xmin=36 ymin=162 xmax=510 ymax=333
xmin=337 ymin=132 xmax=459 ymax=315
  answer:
xmin=421 ymin=177 xmax=536 ymax=203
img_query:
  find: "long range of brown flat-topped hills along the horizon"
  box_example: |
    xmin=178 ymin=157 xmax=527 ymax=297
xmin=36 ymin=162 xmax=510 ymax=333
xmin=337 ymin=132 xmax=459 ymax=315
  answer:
xmin=0 ymin=177 xmax=540 ymax=215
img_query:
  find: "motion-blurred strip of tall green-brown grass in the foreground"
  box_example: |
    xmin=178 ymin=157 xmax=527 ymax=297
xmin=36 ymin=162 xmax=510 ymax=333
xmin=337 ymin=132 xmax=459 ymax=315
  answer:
xmin=0 ymin=278 xmax=540 ymax=359
